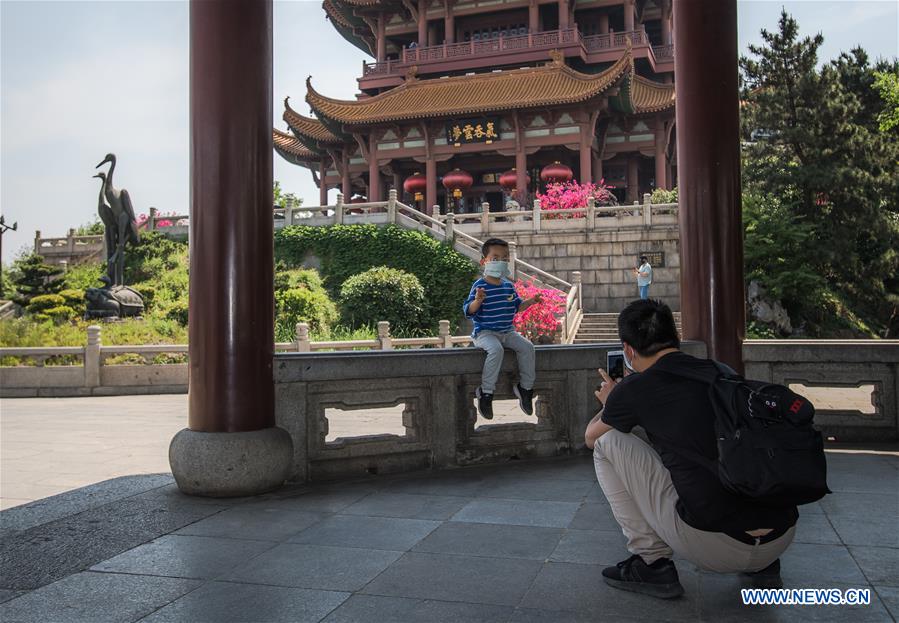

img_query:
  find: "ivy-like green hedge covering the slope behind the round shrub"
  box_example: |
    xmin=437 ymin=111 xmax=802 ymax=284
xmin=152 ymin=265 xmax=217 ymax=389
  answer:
xmin=275 ymin=225 xmax=477 ymax=331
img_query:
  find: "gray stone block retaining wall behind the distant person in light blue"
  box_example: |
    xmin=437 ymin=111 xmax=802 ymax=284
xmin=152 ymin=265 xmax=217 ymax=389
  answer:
xmin=510 ymin=225 xmax=680 ymax=313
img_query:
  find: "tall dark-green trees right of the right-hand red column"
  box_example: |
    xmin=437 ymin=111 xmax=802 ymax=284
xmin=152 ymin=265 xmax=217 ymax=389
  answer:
xmin=740 ymin=11 xmax=899 ymax=335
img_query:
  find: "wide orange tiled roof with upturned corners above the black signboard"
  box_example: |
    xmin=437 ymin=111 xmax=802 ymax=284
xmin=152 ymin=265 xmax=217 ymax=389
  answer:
xmin=306 ymin=52 xmax=632 ymax=124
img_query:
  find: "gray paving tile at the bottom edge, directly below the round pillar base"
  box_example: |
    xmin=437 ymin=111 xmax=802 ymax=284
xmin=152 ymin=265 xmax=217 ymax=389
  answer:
xmin=141 ymin=582 xmax=350 ymax=623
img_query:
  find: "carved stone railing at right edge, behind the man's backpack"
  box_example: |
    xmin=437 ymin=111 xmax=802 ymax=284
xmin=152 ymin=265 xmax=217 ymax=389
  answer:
xmin=743 ymin=340 xmax=899 ymax=442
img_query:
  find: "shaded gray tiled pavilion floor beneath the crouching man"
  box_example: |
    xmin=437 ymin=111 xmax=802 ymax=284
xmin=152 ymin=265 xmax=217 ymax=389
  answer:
xmin=0 ymin=452 xmax=899 ymax=623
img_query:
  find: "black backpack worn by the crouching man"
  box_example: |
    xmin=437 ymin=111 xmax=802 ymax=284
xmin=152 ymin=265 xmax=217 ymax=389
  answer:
xmin=666 ymin=362 xmax=831 ymax=507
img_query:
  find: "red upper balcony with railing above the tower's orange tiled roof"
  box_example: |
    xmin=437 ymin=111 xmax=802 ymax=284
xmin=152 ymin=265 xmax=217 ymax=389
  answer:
xmin=358 ymin=27 xmax=674 ymax=90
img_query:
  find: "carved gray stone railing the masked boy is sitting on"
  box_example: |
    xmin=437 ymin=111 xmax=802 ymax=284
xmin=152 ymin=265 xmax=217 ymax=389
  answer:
xmin=274 ymin=343 xmax=705 ymax=481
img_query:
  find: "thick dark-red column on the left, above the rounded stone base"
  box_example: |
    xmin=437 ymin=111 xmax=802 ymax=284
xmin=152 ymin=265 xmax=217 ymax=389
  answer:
xmin=189 ymin=0 xmax=275 ymax=434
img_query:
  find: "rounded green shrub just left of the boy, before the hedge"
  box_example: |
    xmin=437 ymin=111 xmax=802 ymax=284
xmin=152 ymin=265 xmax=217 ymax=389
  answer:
xmin=340 ymin=266 xmax=425 ymax=332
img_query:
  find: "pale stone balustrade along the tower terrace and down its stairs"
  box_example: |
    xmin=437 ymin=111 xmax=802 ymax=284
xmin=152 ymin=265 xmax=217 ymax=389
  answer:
xmin=284 ymin=189 xmax=592 ymax=344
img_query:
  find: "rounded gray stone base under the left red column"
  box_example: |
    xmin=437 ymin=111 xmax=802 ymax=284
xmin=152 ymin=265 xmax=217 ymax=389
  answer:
xmin=169 ymin=427 xmax=293 ymax=497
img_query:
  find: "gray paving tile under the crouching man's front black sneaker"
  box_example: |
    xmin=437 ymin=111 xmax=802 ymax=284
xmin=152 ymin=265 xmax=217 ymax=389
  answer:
xmin=519 ymin=562 xmax=699 ymax=621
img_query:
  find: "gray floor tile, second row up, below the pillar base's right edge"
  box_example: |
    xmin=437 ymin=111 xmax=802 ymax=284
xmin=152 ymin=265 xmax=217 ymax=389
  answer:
xmin=223 ymin=543 xmax=402 ymax=592
